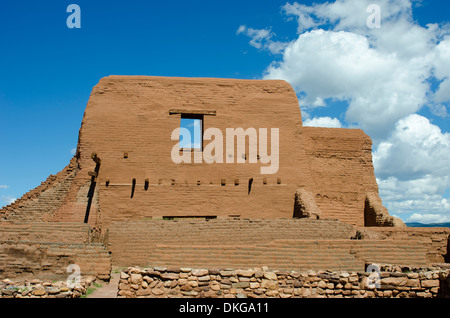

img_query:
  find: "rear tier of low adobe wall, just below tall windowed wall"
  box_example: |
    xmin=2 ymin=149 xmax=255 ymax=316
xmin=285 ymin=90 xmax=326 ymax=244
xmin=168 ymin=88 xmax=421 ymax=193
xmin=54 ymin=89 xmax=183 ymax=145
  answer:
xmin=108 ymin=219 xmax=355 ymax=266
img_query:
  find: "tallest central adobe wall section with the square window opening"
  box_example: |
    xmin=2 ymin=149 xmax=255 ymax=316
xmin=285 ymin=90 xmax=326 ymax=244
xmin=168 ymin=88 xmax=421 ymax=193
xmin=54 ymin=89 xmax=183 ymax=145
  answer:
xmin=75 ymin=76 xmax=312 ymax=226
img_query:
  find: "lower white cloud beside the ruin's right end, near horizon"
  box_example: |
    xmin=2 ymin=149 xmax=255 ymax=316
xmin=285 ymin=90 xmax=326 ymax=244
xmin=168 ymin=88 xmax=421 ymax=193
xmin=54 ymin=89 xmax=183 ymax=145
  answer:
xmin=373 ymin=114 xmax=450 ymax=221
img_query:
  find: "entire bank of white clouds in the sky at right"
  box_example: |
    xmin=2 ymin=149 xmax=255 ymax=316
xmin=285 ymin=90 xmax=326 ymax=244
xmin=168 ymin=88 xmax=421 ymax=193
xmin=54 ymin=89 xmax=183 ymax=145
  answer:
xmin=238 ymin=0 xmax=450 ymax=223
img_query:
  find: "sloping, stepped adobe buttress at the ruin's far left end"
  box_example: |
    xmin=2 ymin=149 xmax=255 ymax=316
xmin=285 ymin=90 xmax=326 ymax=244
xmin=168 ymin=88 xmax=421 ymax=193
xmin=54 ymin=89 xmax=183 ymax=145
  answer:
xmin=0 ymin=157 xmax=77 ymax=222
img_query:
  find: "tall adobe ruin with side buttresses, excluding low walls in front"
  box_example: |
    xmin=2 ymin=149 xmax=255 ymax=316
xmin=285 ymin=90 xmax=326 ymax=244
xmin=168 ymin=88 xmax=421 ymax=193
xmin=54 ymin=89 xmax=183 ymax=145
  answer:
xmin=0 ymin=76 xmax=399 ymax=229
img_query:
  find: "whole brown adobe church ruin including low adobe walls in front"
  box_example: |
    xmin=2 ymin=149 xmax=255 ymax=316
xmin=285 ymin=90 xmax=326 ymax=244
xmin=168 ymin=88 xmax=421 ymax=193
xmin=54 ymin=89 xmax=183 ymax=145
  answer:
xmin=0 ymin=76 xmax=450 ymax=288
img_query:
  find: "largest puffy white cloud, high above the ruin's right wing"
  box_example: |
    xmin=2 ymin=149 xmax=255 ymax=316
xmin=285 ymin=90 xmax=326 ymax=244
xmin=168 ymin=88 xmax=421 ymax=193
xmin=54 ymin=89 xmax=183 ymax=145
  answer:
xmin=264 ymin=16 xmax=442 ymax=139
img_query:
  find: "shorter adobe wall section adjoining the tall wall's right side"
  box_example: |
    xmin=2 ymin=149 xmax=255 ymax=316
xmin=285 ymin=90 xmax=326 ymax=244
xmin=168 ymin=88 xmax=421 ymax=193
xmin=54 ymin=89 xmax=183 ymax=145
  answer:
xmin=303 ymin=127 xmax=384 ymax=226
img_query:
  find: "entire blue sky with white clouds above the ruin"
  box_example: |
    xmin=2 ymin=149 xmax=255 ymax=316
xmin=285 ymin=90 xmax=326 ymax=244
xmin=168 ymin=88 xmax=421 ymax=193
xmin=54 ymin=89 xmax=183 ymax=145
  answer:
xmin=0 ymin=0 xmax=450 ymax=222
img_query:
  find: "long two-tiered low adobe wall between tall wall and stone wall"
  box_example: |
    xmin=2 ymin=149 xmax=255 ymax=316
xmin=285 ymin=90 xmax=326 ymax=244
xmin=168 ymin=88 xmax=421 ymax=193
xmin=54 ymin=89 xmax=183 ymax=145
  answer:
xmin=108 ymin=219 xmax=429 ymax=271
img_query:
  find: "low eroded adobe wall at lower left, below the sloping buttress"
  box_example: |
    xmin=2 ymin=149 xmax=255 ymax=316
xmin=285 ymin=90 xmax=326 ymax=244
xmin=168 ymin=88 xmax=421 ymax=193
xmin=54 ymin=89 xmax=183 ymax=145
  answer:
xmin=0 ymin=221 xmax=112 ymax=280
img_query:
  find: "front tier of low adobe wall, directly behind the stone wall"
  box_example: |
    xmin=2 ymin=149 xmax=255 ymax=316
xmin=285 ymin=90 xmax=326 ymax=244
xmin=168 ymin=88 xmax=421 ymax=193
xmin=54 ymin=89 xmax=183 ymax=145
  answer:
xmin=141 ymin=240 xmax=427 ymax=271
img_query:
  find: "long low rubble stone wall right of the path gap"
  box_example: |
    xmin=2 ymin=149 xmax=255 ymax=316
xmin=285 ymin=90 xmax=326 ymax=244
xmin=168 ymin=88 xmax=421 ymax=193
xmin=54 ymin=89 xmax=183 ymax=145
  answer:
xmin=118 ymin=266 xmax=450 ymax=298
